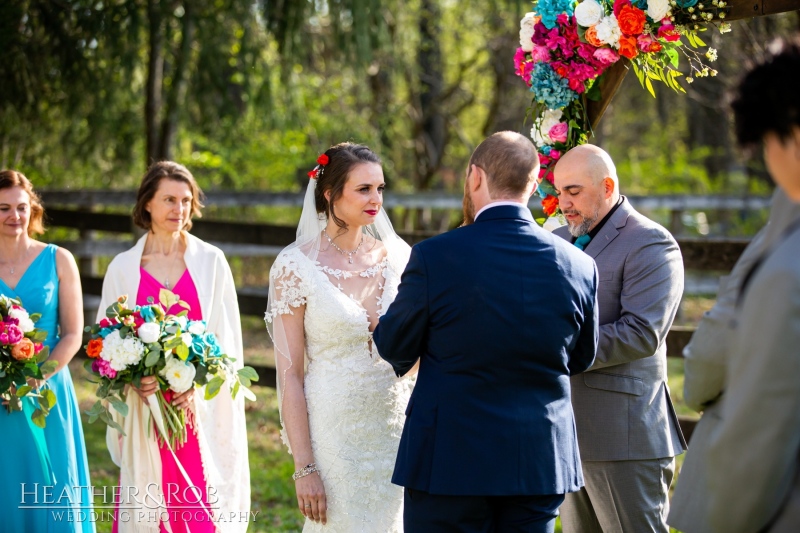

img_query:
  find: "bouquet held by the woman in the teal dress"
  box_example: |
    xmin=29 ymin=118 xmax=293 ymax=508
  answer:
xmin=0 ymin=296 xmax=57 ymax=427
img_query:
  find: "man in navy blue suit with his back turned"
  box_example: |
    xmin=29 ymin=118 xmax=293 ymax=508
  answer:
xmin=374 ymin=132 xmax=598 ymax=533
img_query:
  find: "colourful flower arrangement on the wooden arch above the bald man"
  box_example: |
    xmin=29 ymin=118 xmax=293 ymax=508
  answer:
xmin=514 ymin=0 xmax=731 ymax=217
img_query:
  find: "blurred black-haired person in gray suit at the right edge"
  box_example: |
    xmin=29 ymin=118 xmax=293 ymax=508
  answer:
xmin=704 ymin=38 xmax=800 ymax=533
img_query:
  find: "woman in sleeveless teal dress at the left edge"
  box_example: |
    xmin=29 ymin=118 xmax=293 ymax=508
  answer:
xmin=0 ymin=170 xmax=95 ymax=533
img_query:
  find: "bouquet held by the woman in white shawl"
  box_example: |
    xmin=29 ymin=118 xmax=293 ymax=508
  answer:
xmin=86 ymin=289 xmax=258 ymax=448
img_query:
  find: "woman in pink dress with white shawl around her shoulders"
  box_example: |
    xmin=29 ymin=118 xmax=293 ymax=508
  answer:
xmin=98 ymin=161 xmax=250 ymax=533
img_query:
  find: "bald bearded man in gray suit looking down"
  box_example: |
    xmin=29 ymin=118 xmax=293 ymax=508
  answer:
xmin=555 ymin=144 xmax=686 ymax=533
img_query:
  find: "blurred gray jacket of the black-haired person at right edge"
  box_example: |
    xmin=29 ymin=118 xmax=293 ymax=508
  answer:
xmin=703 ymin=202 xmax=800 ymax=533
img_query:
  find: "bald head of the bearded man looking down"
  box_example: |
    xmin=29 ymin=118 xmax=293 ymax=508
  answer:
xmin=553 ymin=144 xmax=619 ymax=237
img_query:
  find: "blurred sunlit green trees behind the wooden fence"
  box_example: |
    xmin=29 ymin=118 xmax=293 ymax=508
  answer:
xmin=0 ymin=0 xmax=800 ymax=208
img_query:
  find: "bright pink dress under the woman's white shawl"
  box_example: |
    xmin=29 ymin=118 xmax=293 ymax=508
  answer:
xmin=114 ymin=268 xmax=215 ymax=533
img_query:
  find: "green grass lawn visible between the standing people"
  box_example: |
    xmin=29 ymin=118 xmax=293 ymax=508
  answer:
xmin=75 ymin=328 xmax=696 ymax=533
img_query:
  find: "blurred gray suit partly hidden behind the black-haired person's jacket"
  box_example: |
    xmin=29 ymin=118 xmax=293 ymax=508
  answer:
xmin=667 ymin=189 xmax=800 ymax=533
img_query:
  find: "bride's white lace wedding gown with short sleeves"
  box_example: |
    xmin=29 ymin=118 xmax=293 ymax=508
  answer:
xmin=267 ymin=249 xmax=413 ymax=533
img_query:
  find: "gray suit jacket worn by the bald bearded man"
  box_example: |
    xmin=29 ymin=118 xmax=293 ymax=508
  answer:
xmin=554 ymin=197 xmax=686 ymax=461
